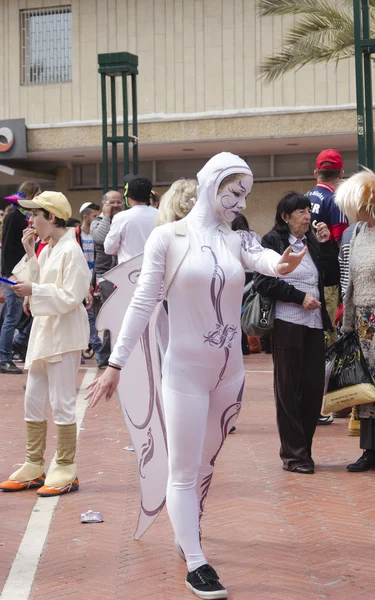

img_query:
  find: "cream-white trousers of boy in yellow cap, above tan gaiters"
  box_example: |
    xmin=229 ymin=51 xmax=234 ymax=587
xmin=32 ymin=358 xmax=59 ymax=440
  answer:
xmin=25 ymin=350 xmax=81 ymax=425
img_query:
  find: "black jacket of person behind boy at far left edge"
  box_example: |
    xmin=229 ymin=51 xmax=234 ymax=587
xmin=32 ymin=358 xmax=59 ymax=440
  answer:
xmin=1 ymin=206 xmax=27 ymax=277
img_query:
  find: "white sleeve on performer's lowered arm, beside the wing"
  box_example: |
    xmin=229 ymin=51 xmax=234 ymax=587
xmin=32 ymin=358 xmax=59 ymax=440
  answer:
xmin=109 ymin=226 xmax=173 ymax=367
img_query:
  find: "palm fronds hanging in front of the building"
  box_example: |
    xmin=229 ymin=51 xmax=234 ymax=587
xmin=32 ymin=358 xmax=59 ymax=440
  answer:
xmin=258 ymin=0 xmax=375 ymax=83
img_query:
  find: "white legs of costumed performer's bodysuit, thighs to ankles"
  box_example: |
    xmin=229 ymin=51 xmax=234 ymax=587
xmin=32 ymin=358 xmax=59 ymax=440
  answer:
xmin=163 ymin=376 xmax=244 ymax=571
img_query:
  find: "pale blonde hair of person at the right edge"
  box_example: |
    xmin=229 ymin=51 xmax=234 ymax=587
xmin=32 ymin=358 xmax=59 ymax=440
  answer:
xmin=335 ymin=169 xmax=375 ymax=223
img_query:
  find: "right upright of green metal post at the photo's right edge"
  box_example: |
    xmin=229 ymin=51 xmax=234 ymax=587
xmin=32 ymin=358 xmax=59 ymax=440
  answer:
xmin=362 ymin=0 xmax=374 ymax=170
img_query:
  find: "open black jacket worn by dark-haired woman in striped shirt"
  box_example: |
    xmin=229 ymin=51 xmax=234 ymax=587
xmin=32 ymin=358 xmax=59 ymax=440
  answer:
xmin=254 ymin=230 xmax=340 ymax=331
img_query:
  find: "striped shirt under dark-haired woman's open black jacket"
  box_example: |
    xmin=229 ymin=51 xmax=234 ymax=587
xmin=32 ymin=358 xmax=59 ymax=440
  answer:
xmin=275 ymin=235 xmax=323 ymax=329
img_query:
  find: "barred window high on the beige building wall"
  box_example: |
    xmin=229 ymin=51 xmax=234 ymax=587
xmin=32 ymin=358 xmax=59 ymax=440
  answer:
xmin=20 ymin=6 xmax=72 ymax=85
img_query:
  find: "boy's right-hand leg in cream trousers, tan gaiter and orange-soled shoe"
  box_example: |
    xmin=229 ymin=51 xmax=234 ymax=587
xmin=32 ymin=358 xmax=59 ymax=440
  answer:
xmin=38 ymin=351 xmax=81 ymax=496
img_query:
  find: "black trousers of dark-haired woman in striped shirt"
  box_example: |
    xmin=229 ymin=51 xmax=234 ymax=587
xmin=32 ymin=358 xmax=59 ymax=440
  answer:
xmin=271 ymin=319 xmax=325 ymax=468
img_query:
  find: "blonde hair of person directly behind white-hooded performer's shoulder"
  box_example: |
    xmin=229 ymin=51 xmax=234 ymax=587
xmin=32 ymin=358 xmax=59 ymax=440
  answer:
xmin=157 ymin=179 xmax=198 ymax=225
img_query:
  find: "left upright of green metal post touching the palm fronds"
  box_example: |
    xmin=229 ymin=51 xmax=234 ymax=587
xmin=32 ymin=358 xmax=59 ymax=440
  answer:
xmin=353 ymin=0 xmax=366 ymax=169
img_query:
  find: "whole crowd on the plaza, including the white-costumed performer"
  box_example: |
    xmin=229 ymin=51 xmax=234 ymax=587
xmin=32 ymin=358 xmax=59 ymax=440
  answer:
xmin=0 ymin=149 xmax=375 ymax=598
